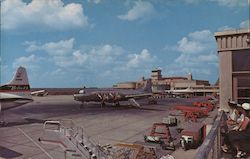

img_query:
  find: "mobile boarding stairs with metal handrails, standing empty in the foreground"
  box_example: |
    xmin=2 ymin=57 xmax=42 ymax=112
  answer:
xmin=38 ymin=120 xmax=108 ymax=159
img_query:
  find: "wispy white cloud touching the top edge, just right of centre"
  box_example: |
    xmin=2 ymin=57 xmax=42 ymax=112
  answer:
xmin=117 ymin=1 xmax=155 ymax=21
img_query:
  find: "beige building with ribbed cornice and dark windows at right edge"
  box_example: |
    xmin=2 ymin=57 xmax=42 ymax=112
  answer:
xmin=215 ymin=29 xmax=250 ymax=110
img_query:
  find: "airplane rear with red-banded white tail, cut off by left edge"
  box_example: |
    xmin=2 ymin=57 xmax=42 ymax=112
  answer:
xmin=0 ymin=67 xmax=33 ymax=112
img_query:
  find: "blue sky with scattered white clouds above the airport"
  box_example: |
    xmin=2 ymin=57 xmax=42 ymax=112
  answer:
xmin=0 ymin=0 xmax=249 ymax=88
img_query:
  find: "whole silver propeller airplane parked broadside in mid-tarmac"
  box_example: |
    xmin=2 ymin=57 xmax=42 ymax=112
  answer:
xmin=73 ymin=80 xmax=152 ymax=108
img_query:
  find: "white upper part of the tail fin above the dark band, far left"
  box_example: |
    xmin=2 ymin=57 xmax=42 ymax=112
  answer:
xmin=8 ymin=66 xmax=29 ymax=86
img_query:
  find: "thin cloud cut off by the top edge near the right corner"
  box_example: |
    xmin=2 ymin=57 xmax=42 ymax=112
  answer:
xmin=210 ymin=0 xmax=247 ymax=7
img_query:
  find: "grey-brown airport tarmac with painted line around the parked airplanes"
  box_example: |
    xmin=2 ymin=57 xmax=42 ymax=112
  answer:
xmin=0 ymin=95 xmax=213 ymax=159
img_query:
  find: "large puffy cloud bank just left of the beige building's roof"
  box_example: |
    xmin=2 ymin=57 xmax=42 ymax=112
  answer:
xmin=165 ymin=30 xmax=218 ymax=79
